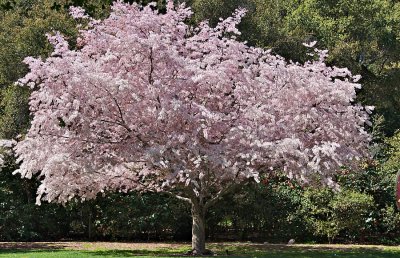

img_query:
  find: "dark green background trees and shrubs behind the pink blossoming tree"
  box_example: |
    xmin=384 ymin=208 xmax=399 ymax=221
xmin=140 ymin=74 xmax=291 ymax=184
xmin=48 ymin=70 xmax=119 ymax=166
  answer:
xmin=0 ymin=0 xmax=400 ymax=244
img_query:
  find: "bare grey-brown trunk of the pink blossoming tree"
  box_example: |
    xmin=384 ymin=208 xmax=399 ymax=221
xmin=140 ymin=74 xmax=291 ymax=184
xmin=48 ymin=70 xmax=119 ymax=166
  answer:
xmin=192 ymin=204 xmax=206 ymax=255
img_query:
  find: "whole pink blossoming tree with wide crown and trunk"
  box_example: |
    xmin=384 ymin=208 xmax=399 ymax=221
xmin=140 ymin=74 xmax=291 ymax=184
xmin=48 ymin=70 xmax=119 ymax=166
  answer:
xmin=14 ymin=1 xmax=369 ymax=254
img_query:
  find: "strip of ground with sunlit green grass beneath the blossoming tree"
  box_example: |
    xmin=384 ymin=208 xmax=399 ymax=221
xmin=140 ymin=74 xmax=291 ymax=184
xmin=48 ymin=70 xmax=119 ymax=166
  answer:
xmin=0 ymin=242 xmax=400 ymax=258
